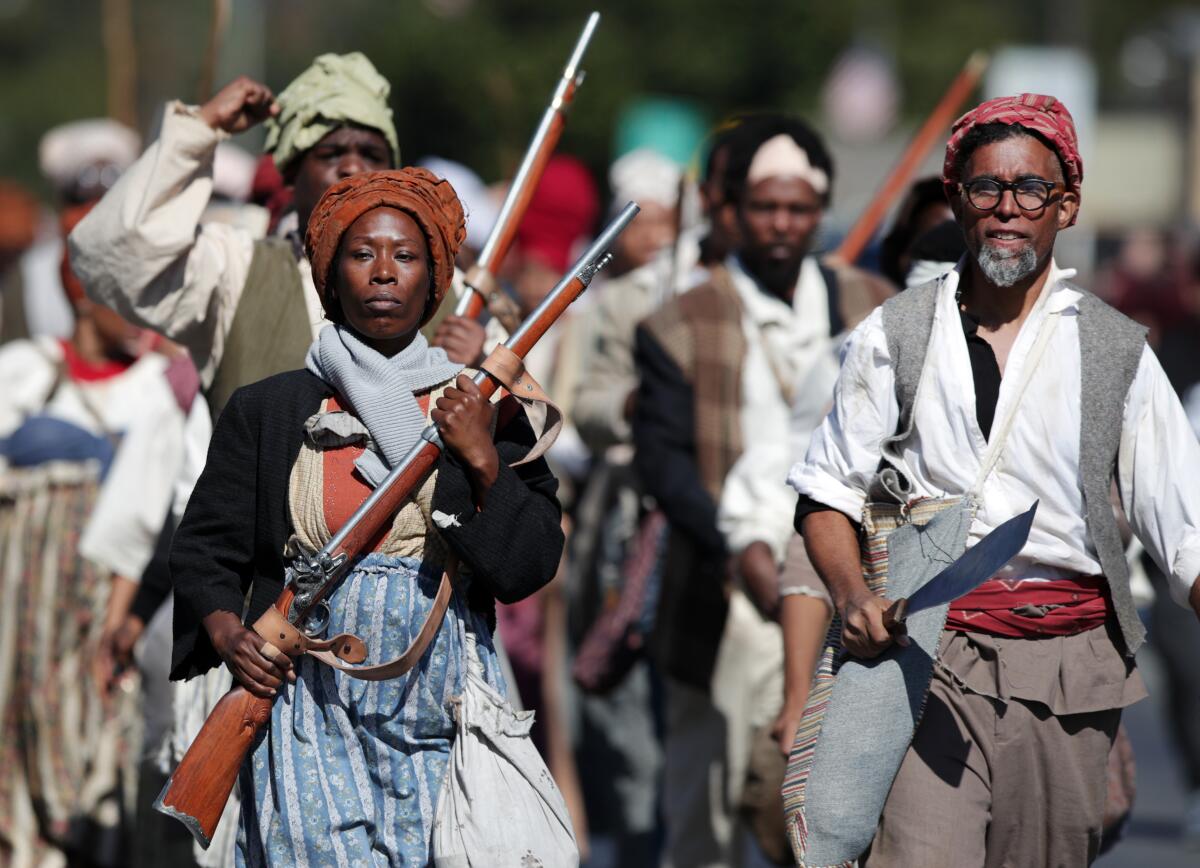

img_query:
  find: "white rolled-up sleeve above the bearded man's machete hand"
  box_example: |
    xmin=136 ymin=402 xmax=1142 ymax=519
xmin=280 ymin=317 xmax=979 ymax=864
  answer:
xmin=787 ymin=309 xmax=900 ymax=522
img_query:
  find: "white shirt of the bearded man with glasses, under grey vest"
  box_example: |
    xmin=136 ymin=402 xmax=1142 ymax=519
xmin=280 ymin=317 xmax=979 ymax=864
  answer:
xmin=788 ymin=264 xmax=1200 ymax=607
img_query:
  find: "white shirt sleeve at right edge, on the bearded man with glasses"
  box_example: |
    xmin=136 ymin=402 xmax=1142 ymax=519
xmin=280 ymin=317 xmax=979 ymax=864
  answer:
xmin=1117 ymin=346 xmax=1200 ymax=603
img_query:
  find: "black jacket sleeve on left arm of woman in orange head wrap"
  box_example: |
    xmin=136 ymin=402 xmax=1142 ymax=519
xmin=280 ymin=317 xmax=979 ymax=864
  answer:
xmin=170 ymin=390 xmax=258 ymax=659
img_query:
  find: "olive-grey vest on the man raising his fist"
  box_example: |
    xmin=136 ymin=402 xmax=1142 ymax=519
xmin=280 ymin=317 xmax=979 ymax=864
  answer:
xmin=206 ymin=238 xmax=312 ymax=419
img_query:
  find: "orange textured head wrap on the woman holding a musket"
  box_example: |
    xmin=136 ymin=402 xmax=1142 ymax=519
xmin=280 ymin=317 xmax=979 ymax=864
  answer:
xmin=304 ymin=168 xmax=467 ymax=325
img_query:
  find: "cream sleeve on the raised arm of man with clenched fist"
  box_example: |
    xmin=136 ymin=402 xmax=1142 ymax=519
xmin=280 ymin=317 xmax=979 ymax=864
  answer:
xmin=68 ymin=102 xmax=254 ymax=387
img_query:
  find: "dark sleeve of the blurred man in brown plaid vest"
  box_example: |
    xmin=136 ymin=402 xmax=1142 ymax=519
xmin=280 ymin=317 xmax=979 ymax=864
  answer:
xmin=632 ymin=328 xmax=725 ymax=555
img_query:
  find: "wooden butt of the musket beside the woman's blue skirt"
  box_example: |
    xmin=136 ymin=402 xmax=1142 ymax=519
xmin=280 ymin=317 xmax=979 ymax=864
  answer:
xmin=154 ymin=686 xmax=272 ymax=850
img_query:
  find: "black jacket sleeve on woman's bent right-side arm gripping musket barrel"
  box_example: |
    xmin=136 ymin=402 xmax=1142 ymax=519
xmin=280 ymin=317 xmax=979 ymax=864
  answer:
xmin=433 ymin=403 xmax=563 ymax=603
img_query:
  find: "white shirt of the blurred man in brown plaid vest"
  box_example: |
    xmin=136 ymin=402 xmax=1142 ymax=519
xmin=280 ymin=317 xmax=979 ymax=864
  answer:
xmin=718 ymin=257 xmax=838 ymax=563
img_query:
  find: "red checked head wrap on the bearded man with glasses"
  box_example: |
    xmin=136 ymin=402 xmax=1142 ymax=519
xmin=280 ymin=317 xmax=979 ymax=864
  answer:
xmin=942 ymin=94 xmax=1084 ymax=222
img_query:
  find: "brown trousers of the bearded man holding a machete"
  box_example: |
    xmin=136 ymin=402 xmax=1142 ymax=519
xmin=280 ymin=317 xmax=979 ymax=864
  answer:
xmin=862 ymin=666 xmax=1121 ymax=868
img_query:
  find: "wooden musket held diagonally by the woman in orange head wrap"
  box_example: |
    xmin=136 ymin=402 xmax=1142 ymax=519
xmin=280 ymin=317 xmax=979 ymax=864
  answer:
xmin=155 ymin=202 xmax=638 ymax=848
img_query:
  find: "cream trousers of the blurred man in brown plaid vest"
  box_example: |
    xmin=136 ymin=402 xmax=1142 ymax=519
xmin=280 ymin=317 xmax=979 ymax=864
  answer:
xmin=662 ymin=591 xmax=784 ymax=868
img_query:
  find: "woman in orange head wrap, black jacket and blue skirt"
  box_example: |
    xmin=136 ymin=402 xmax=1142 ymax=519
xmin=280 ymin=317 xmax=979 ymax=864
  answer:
xmin=172 ymin=169 xmax=563 ymax=864
